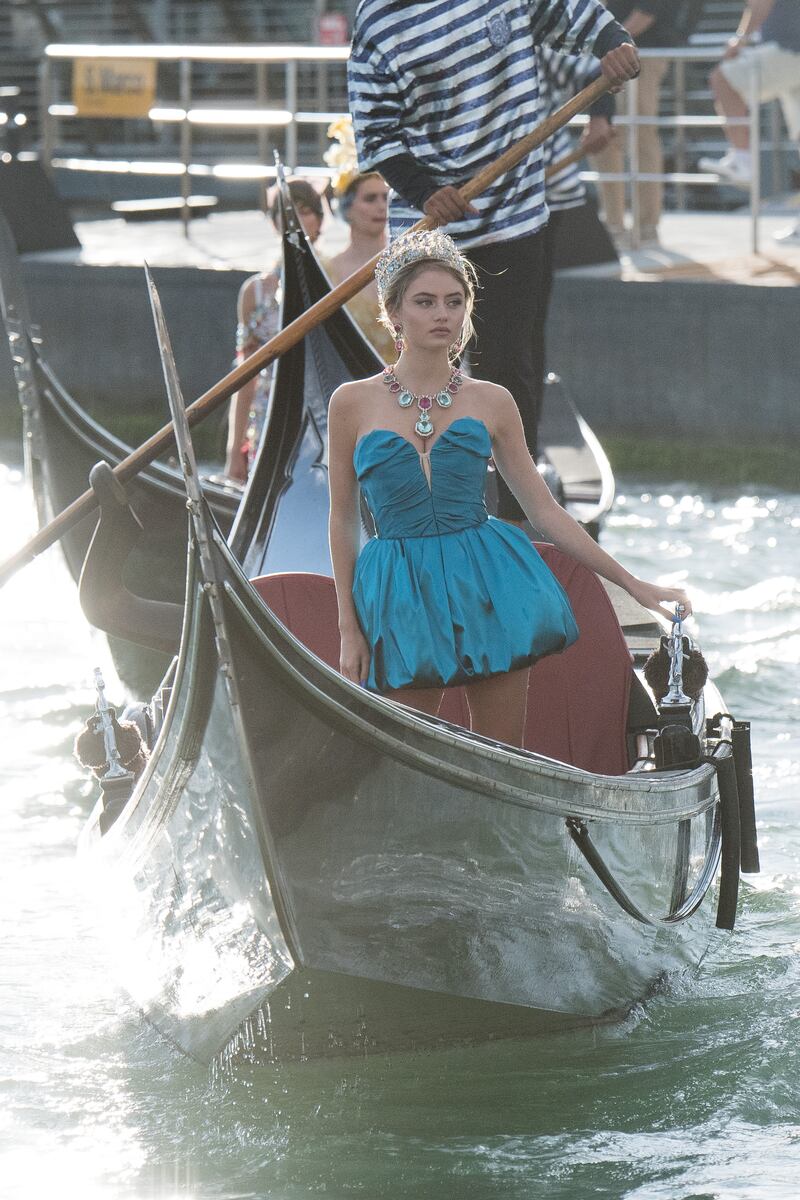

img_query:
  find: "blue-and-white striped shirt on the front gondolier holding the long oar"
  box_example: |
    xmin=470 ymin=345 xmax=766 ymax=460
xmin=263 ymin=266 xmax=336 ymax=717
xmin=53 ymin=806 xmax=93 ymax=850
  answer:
xmin=348 ymin=0 xmax=628 ymax=247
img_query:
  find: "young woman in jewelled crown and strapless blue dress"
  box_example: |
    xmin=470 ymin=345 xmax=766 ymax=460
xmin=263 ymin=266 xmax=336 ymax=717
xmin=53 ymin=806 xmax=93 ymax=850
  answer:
xmin=329 ymin=230 xmax=691 ymax=745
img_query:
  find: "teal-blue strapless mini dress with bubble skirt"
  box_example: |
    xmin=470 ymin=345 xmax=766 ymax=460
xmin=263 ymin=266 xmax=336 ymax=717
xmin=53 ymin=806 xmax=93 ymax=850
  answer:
xmin=353 ymin=416 xmax=578 ymax=692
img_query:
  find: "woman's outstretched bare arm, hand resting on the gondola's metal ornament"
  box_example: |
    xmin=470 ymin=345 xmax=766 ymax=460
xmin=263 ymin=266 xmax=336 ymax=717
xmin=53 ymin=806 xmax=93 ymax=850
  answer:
xmin=493 ymin=388 xmax=692 ymax=618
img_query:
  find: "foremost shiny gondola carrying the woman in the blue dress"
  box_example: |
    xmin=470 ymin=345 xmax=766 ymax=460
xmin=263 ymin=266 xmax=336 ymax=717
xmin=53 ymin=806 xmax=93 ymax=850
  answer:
xmin=71 ymin=240 xmax=758 ymax=1060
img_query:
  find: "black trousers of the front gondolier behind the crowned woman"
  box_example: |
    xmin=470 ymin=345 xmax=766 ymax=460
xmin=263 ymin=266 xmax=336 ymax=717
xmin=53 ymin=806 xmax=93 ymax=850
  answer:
xmin=467 ymin=230 xmax=552 ymax=520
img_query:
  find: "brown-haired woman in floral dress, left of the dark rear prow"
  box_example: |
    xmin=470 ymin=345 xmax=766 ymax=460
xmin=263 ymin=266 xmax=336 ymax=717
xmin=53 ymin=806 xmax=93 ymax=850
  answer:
xmin=224 ymin=179 xmax=323 ymax=484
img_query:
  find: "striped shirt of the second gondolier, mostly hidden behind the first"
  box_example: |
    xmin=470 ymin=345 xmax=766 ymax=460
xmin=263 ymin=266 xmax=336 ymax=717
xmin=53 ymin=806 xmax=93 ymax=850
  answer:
xmin=536 ymin=47 xmax=599 ymax=212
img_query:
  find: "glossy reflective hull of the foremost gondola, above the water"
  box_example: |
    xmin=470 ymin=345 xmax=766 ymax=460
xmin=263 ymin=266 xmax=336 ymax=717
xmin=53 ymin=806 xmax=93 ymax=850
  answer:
xmin=81 ymin=523 xmax=718 ymax=1058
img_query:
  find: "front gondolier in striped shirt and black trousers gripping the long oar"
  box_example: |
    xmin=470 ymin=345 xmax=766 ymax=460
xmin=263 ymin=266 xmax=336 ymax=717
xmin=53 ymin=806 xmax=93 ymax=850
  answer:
xmin=348 ymin=0 xmax=638 ymax=520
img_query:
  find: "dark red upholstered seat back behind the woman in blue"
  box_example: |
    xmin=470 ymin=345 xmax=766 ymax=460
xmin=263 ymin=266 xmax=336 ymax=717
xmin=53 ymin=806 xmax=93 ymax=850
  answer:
xmin=253 ymin=545 xmax=631 ymax=775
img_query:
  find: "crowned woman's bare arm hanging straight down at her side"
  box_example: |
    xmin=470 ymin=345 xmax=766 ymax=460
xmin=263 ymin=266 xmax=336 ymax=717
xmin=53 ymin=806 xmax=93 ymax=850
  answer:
xmin=327 ymin=384 xmax=369 ymax=683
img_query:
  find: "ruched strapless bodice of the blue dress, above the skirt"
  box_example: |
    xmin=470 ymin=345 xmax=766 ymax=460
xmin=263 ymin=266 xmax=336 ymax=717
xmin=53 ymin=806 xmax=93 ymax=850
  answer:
xmin=354 ymin=416 xmax=492 ymax=538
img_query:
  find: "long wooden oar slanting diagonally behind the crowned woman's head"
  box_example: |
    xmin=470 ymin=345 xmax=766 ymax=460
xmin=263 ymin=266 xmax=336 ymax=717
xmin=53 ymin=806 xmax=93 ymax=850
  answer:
xmin=0 ymin=76 xmax=612 ymax=587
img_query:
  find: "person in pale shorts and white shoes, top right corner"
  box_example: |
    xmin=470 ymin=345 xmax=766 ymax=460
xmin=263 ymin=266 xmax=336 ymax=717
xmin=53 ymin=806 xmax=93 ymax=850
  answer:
xmin=698 ymin=0 xmax=800 ymax=242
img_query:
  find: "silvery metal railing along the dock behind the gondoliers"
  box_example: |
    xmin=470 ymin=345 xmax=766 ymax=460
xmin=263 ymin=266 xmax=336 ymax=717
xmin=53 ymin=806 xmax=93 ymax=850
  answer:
xmin=40 ymin=43 xmax=796 ymax=253
